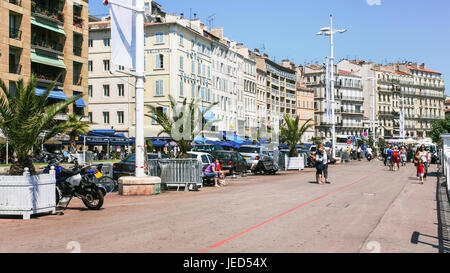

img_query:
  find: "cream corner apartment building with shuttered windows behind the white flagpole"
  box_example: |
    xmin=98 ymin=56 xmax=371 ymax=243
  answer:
xmin=89 ymin=6 xmax=217 ymax=137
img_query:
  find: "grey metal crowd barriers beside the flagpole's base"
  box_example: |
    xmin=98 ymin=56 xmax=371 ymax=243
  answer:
xmin=148 ymin=159 xmax=203 ymax=191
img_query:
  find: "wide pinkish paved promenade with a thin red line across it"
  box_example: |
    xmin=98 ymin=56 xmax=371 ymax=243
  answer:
xmin=0 ymin=160 xmax=448 ymax=253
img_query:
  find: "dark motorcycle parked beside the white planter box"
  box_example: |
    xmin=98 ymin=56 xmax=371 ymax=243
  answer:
xmin=44 ymin=154 xmax=106 ymax=210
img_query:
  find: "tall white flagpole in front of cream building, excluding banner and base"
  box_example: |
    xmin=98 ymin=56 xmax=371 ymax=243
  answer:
xmin=136 ymin=0 xmax=146 ymax=177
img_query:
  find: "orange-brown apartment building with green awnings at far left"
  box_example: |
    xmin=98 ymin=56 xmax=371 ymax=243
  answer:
xmin=0 ymin=0 xmax=89 ymax=119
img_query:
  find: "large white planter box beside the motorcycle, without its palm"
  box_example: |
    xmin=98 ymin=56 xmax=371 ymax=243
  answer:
xmin=0 ymin=168 xmax=56 ymax=220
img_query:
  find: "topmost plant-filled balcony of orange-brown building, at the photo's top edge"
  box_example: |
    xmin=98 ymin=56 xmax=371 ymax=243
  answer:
xmin=31 ymin=1 xmax=64 ymax=24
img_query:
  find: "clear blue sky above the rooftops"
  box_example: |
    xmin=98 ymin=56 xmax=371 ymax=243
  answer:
xmin=89 ymin=0 xmax=450 ymax=95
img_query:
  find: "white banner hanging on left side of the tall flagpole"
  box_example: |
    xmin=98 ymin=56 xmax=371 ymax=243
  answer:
xmin=111 ymin=0 xmax=136 ymax=69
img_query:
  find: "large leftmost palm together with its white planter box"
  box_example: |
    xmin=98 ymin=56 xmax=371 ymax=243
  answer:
xmin=0 ymin=75 xmax=80 ymax=219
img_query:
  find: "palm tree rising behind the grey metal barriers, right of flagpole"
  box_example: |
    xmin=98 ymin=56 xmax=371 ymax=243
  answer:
xmin=145 ymin=95 xmax=218 ymax=158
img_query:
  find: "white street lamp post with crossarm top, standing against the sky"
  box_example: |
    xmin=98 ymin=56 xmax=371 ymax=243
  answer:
xmin=317 ymin=15 xmax=347 ymax=158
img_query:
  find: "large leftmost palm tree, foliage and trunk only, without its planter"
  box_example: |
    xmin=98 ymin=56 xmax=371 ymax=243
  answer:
xmin=0 ymin=76 xmax=81 ymax=175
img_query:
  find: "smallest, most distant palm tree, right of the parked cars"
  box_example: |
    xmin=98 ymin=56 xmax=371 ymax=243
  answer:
xmin=280 ymin=115 xmax=312 ymax=157
